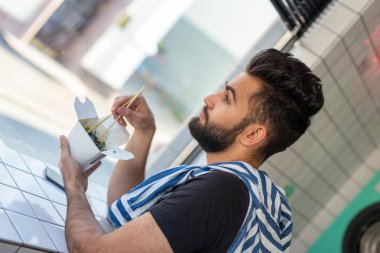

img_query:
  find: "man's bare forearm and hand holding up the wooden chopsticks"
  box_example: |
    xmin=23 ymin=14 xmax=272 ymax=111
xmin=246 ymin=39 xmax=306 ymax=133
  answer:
xmin=107 ymin=96 xmax=156 ymax=207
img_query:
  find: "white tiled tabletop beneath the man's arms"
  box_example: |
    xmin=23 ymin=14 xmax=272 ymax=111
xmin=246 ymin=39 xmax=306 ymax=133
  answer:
xmin=0 ymin=146 xmax=112 ymax=253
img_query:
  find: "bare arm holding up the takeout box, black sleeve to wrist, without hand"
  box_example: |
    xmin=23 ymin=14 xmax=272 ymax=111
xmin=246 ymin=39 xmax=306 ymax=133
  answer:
xmin=66 ymin=184 xmax=173 ymax=253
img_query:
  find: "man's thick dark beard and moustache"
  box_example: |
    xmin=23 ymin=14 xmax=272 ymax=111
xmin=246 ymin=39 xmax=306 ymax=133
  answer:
xmin=189 ymin=116 xmax=249 ymax=153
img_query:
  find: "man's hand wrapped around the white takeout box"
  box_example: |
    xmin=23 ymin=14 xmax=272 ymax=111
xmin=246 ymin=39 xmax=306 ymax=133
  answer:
xmin=59 ymin=135 xmax=101 ymax=192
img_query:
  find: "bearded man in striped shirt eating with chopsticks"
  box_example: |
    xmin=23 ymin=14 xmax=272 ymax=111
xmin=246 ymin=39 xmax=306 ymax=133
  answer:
xmin=60 ymin=49 xmax=324 ymax=253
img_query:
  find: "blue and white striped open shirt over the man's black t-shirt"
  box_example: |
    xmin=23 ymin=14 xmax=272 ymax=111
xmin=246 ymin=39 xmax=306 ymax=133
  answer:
xmin=108 ymin=162 xmax=292 ymax=252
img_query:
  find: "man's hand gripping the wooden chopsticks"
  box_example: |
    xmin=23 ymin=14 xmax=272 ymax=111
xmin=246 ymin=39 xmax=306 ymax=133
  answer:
xmin=111 ymin=96 xmax=156 ymax=132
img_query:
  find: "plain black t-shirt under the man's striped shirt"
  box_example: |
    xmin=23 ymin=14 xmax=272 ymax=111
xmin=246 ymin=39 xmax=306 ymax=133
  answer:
xmin=148 ymin=171 xmax=249 ymax=253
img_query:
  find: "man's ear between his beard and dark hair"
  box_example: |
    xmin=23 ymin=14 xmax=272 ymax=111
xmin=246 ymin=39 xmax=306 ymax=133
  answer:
xmin=239 ymin=124 xmax=268 ymax=146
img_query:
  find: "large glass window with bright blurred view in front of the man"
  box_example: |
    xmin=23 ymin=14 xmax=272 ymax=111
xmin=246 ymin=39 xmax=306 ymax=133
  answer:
xmin=0 ymin=0 xmax=285 ymax=185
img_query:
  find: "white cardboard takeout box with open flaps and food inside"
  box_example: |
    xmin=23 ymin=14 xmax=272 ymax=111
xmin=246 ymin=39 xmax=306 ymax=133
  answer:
xmin=67 ymin=97 xmax=134 ymax=170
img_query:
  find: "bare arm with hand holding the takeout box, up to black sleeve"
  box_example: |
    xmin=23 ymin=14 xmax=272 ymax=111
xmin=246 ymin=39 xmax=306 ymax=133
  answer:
xmin=59 ymin=137 xmax=173 ymax=253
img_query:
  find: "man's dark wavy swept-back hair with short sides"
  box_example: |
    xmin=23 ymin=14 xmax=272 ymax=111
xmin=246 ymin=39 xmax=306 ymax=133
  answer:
xmin=246 ymin=49 xmax=324 ymax=161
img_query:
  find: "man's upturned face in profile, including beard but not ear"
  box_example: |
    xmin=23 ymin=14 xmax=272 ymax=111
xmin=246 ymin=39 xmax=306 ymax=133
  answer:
xmin=189 ymin=72 xmax=261 ymax=153
